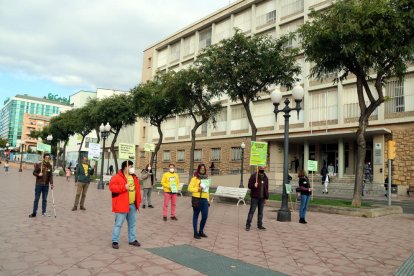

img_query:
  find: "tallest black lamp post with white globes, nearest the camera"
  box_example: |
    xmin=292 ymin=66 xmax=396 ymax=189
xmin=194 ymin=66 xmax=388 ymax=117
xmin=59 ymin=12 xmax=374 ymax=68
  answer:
xmin=270 ymin=84 xmax=304 ymax=221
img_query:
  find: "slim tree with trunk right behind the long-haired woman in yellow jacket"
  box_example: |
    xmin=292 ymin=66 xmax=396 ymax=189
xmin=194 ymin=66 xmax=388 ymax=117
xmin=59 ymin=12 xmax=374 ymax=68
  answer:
xmin=170 ymin=68 xmax=222 ymax=181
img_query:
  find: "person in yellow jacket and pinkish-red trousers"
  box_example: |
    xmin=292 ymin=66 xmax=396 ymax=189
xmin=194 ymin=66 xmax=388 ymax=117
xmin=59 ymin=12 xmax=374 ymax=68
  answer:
xmin=161 ymin=164 xmax=180 ymax=221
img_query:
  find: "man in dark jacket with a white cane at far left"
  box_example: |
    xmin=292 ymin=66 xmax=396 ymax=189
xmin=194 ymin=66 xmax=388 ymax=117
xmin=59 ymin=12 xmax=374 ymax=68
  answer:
xmin=29 ymin=153 xmax=53 ymax=218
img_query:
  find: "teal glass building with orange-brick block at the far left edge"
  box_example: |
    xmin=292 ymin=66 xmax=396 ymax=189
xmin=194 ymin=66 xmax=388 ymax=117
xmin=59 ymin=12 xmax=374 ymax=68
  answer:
xmin=0 ymin=94 xmax=70 ymax=149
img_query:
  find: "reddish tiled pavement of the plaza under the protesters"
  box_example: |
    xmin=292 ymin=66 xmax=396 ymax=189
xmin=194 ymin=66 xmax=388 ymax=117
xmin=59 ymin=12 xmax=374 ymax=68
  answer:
xmin=0 ymin=169 xmax=414 ymax=276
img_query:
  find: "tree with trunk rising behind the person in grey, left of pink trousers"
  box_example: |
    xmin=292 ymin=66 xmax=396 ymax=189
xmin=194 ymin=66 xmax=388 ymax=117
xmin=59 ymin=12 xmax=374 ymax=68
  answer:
xmin=131 ymin=72 xmax=178 ymax=169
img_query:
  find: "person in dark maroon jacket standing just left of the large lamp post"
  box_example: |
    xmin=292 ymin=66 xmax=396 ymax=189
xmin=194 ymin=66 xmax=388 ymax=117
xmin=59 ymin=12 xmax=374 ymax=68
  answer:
xmin=246 ymin=166 xmax=269 ymax=231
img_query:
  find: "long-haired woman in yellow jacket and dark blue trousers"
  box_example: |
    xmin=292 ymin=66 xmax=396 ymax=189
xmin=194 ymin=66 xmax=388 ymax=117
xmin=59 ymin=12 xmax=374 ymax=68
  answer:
xmin=188 ymin=164 xmax=211 ymax=239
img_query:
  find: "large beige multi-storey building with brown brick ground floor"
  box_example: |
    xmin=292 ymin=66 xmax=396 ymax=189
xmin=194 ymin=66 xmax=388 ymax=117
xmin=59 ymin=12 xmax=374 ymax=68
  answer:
xmin=141 ymin=0 xmax=414 ymax=190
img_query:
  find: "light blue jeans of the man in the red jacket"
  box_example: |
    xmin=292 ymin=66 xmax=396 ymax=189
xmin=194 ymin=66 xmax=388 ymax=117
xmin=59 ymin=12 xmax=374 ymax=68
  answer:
xmin=112 ymin=204 xmax=137 ymax=242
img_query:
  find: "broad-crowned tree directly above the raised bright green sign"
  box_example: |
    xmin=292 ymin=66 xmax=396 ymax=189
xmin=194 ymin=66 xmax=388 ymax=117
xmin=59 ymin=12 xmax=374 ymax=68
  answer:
xmin=196 ymin=31 xmax=300 ymax=141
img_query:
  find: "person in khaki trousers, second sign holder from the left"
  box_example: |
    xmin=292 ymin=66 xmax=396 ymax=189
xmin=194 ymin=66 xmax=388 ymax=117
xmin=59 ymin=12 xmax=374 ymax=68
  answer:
xmin=72 ymin=156 xmax=93 ymax=211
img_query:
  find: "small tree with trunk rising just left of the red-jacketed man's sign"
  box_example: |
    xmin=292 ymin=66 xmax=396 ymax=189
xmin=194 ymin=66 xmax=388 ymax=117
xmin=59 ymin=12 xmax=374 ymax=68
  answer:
xmin=91 ymin=94 xmax=137 ymax=171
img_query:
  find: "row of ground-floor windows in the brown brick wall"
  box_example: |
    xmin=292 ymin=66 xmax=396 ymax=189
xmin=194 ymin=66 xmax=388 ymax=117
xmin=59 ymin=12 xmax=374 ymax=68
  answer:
xmin=140 ymin=147 xmax=242 ymax=162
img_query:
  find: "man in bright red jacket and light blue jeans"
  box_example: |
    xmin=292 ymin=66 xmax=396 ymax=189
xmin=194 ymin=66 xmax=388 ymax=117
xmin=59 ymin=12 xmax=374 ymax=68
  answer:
xmin=109 ymin=161 xmax=141 ymax=249
